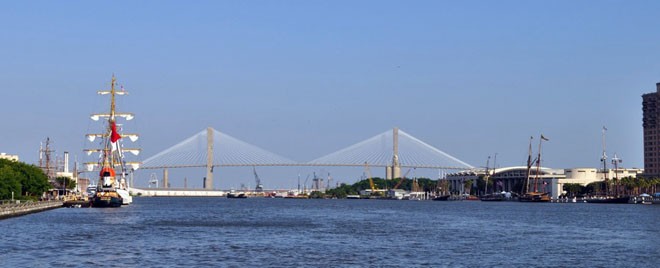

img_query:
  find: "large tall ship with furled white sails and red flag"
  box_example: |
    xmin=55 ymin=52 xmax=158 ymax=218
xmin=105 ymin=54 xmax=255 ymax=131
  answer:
xmin=84 ymin=75 xmax=140 ymax=207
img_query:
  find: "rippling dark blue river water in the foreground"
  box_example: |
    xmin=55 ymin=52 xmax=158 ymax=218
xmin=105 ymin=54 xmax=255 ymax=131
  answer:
xmin=0 ymin=197 xmax=660 ymax=267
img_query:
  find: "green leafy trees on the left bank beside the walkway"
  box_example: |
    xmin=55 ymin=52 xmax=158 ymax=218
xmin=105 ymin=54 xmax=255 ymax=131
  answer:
xmin=0 ymin=159 xmax=51 ymax=200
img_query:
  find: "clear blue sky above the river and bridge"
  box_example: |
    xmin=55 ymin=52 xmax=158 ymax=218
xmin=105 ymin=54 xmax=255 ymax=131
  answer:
xmin=0 ymin=0 xmax=660 ymax=188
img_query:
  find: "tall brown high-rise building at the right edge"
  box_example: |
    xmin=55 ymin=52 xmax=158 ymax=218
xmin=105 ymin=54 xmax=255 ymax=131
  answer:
xmin=642 ymin=83 xmax=660 ymax=177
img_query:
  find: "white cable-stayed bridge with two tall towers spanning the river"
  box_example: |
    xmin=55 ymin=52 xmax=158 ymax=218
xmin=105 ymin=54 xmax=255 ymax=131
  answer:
xmin=141 ymin=128 xmax=473 ymax=189
